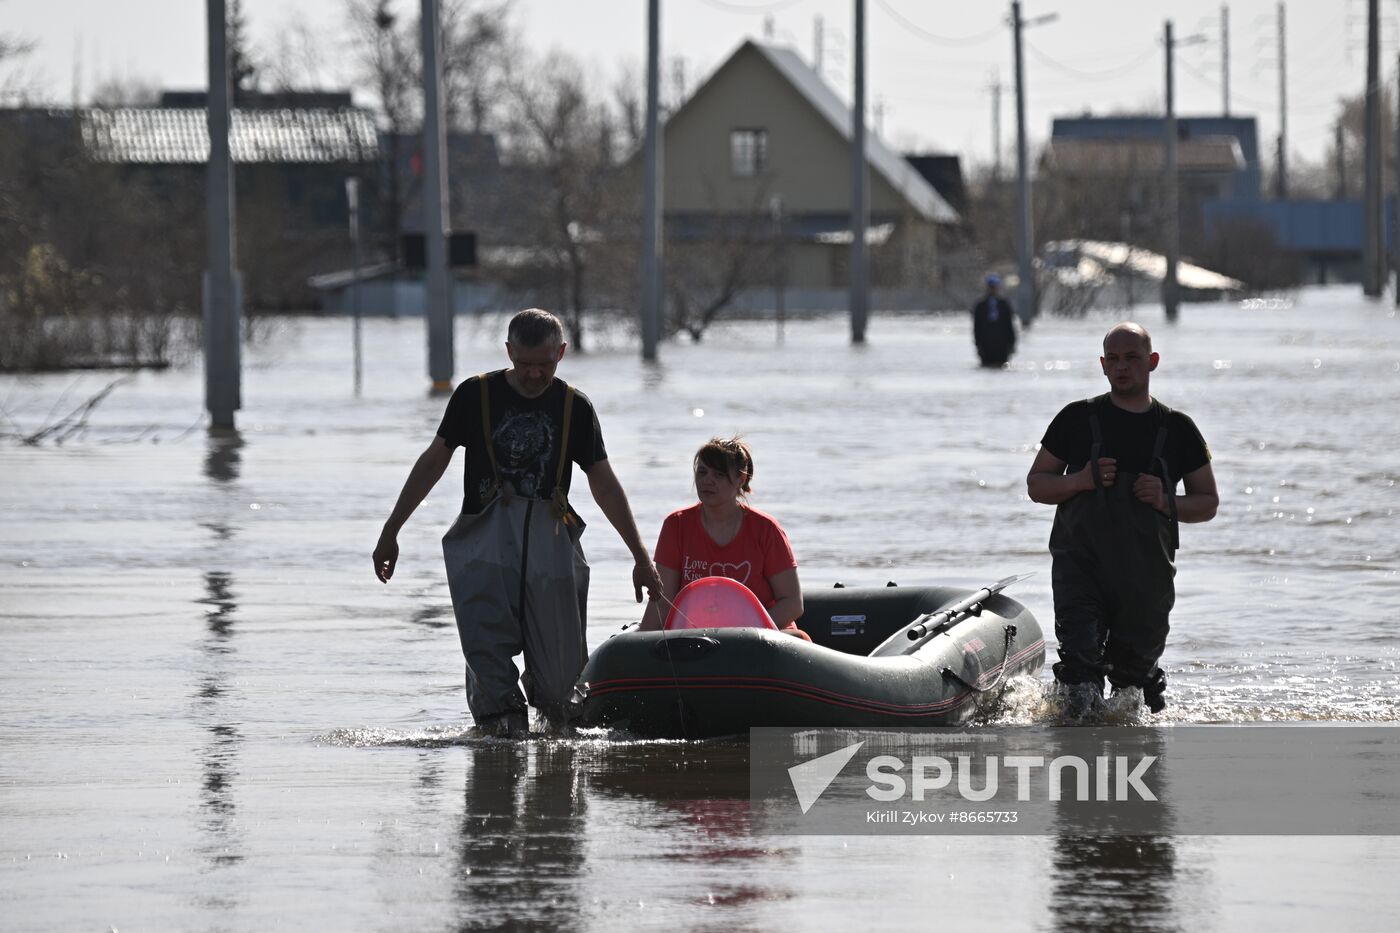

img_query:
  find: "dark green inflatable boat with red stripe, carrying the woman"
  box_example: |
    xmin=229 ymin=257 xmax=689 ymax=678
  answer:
xmin=573 ymin=577 xmax=1044 ymax=738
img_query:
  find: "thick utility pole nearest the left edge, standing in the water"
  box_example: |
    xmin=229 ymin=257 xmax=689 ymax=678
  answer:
xmin=204 ymin=0 xmax=242 ymax=430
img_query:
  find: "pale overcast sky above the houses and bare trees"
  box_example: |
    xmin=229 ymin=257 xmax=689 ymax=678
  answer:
xmin=0 ymin=0 xmax=1400 ymax=167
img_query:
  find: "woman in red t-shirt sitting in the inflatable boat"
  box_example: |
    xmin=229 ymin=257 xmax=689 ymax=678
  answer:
xmin=640 ymin=437 xmax=811 ymax=640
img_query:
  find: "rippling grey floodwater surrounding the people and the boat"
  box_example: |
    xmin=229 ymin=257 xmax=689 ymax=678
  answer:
xmin=0 ymin=289 xmax=1400 ymax=932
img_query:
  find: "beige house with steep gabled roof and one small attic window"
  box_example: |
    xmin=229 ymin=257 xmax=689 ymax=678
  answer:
xmin=662 ymin=39 xmax=960 ymax=300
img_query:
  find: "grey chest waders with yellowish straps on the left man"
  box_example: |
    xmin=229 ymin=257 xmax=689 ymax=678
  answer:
xmin=442 ymin=375 xmax=588 ymax=721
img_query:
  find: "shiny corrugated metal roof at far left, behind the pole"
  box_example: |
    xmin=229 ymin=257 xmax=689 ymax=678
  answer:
xmin=78 ymin=106 xmax=378 ymax=165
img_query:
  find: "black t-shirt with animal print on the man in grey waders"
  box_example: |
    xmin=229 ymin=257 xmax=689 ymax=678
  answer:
xmin=438 ymin=370 xmax=608 ymax=514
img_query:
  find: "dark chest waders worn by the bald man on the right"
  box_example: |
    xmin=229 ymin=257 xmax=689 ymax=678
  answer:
xmin=1050 ymin=401 xmax=1177 ymax=712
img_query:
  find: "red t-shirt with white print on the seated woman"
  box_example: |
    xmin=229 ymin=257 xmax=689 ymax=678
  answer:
xmin=655 ymin=503 xmax=797 ymax=609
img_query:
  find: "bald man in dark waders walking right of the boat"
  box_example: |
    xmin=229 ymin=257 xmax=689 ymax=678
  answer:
xmin=1026 ymin=322 xmax=1219 ymax=713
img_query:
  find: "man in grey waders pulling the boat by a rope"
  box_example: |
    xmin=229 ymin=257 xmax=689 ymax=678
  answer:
xmin=374 ymin=308 xmax=661 ymax=737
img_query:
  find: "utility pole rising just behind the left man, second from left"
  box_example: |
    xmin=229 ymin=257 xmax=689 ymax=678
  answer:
xmin=421 ymin=0 xmax=454 ymax=394
